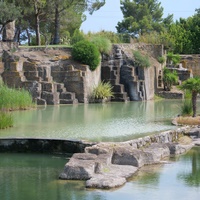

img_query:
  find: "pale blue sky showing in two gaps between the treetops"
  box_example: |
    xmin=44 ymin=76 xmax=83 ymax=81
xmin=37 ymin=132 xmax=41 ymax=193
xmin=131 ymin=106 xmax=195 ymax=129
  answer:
xmin=81 ymin=0 xmax=200 ymax=33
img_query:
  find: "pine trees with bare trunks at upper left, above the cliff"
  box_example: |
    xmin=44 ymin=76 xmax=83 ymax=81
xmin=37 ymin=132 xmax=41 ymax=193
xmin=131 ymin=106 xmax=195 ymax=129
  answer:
xmin=0 ymin=0 xmax=105 ymax=45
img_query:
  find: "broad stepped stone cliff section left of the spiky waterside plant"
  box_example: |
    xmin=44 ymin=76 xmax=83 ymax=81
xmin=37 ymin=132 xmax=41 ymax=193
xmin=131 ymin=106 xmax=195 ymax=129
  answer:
xmin=2 ymin=48 xmax=101 ymax=105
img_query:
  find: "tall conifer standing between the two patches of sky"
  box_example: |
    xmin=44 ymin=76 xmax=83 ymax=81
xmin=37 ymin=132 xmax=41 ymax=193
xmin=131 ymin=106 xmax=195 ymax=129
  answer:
xmin=116 ymin=0 xmax=163 ymax=36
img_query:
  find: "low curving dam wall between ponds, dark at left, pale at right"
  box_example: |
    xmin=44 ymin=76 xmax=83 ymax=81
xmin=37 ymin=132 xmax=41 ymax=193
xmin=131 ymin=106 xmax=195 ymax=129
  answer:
xmin=0 ymin=127 xmax=190 ymax=153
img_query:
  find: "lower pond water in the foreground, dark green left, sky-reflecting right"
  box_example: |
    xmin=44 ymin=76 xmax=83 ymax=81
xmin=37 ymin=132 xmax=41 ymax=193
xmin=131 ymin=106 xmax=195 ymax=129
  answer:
xmin=0 ymin=147 xmax=200 ymax=200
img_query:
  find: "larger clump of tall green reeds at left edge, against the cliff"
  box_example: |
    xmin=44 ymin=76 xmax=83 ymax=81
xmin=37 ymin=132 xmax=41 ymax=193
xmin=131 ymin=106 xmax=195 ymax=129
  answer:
xmin=0 ymin=84 xmax=34 ymax=110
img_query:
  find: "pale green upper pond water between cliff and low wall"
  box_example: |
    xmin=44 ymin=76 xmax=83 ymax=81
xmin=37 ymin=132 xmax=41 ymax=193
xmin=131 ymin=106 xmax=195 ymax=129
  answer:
xmin=0 ymin=100 xmax=186 ymax=141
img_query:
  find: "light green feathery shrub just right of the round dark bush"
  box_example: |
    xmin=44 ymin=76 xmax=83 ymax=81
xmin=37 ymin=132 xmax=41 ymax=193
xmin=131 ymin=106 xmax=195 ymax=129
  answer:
xmin=91 ymin=36 xmax=112 ymax=54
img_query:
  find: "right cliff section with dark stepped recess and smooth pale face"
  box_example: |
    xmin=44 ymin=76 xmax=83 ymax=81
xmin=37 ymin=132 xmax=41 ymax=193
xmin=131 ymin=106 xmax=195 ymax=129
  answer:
xmin=102 ymin=44 xmax=164 ymax=101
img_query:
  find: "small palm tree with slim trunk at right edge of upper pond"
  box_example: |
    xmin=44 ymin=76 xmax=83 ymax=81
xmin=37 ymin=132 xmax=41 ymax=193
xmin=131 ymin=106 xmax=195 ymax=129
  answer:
xmin=180 ymin=77 xmax=200 ymax=117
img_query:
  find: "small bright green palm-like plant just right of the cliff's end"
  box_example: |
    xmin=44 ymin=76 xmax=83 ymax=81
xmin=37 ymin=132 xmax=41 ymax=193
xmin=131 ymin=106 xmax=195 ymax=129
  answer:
xmin=163 ymin=67 xmax=178 ymax=91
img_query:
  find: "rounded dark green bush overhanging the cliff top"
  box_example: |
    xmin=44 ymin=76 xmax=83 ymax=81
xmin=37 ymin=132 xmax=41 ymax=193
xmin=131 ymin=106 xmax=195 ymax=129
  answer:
xmin=72 ymin=40 xmax=100 ymax=70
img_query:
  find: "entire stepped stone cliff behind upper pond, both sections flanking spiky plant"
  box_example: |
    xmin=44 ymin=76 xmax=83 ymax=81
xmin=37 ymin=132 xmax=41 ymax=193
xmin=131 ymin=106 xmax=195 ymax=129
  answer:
xmin=2 ymin=44 xmax=163 ymax=105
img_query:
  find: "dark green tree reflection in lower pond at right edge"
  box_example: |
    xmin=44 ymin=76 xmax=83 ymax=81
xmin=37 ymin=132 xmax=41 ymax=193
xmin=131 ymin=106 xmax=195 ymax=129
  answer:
xmin=178 ymin=147 xmax=200 ymax=187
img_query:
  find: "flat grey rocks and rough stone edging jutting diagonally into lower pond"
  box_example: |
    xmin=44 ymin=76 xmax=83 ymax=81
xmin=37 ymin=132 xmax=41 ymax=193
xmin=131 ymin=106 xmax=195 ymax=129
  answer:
xmin=59 ymin=126 xmax=200 ymax=189
